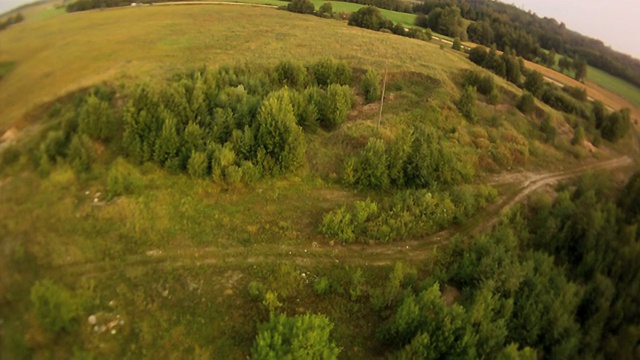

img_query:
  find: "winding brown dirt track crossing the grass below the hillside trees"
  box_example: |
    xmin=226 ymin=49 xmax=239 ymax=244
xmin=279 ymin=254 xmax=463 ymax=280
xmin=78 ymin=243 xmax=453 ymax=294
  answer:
xmin=45 ymin=156 xmax=633 ymax=277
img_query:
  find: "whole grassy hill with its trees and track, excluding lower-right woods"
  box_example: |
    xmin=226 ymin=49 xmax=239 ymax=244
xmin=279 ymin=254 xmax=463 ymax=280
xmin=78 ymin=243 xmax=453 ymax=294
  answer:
xmin=0 ymin=5 xmax=634 ymax=359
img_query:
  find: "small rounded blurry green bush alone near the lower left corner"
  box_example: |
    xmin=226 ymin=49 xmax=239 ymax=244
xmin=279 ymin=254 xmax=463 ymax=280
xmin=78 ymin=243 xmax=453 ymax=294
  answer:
xmin=31 ymin=279 xmax=79 ymax=333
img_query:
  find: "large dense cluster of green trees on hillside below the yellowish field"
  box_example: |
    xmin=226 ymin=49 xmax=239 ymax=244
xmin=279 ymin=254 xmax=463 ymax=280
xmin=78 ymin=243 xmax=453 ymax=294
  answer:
xmin=30 ymin=59 xmax=354 ymax=184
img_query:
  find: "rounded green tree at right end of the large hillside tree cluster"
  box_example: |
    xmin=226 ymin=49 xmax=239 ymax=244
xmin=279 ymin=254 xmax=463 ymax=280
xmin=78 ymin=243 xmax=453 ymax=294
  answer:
xmin=318 ymin=84 xmax=353 ymax=130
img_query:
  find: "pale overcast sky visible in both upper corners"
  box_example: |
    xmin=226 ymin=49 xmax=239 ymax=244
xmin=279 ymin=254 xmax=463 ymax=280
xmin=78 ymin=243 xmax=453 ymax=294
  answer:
xmin=0 ymin=0 xmax=640 ymax=59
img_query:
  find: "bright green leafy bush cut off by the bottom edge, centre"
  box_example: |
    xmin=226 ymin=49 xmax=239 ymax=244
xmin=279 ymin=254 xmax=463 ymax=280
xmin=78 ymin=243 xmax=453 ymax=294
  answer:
xmin=251 ymin=313 xmax=340 ymax=360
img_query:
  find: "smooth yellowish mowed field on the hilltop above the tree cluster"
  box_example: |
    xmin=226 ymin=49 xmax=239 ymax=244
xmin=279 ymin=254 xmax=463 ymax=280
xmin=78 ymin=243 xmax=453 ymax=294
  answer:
xmin=0 ymin=5 xmax=472 ymax=130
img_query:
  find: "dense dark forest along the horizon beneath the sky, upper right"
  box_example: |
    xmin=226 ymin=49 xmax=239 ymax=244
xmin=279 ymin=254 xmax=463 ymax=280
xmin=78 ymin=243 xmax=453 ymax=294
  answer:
xmin=413 ymin=0 xmax=640 ymax=86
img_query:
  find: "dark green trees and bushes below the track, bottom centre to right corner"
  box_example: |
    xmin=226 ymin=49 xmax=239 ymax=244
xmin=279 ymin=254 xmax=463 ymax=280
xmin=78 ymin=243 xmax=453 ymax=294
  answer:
xmin=249 ymin=173 xmax=640 ymax=360
